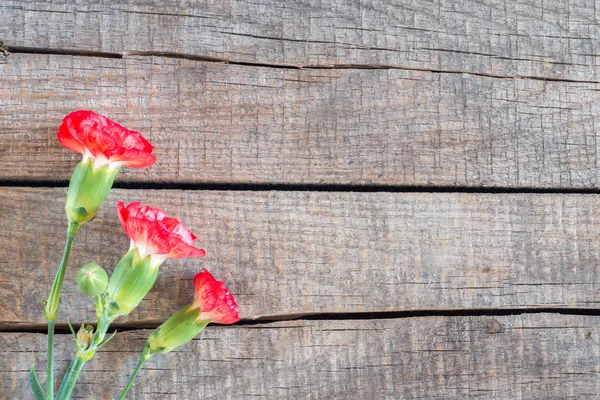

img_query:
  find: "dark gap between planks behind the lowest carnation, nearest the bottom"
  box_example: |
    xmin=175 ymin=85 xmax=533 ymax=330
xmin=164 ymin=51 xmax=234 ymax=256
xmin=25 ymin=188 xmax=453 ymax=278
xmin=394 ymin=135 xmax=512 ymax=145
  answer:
xmin=0 ymin=307 xmax=600 ymax=334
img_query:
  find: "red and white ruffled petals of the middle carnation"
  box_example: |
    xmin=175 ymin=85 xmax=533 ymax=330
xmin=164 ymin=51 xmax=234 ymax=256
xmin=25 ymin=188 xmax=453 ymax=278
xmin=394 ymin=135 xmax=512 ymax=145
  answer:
xmin=117 ymin=201 xmax=206 ymax=264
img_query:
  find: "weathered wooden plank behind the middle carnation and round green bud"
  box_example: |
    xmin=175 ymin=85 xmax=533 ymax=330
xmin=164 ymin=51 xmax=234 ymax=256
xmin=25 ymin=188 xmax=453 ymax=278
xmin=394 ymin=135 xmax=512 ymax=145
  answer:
xmin=0 ymin=188 xmax=600 ymax=327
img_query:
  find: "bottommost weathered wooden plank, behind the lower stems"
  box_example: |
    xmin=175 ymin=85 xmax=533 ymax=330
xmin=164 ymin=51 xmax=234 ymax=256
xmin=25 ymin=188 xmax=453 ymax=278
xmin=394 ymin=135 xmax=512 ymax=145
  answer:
xmin=0 ymin=314 xmax=600 ymax=400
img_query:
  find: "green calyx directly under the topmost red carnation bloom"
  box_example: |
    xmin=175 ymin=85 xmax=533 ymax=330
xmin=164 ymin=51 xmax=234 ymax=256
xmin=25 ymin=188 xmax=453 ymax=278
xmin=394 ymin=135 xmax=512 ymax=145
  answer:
xmin=65 ymin=158 xmax=119 ymax=225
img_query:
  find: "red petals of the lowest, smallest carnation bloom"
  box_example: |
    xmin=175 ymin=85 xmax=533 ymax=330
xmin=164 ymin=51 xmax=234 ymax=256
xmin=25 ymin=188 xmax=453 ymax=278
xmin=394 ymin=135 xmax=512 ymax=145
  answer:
xmin=190 ymin=271 xmax=240 ymax=324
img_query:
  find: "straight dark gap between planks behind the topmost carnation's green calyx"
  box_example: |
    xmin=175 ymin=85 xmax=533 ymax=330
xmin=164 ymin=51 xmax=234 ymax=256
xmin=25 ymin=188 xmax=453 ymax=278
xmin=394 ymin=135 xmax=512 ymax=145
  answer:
xmin=0 ymin=179 xmax=600 ymax=194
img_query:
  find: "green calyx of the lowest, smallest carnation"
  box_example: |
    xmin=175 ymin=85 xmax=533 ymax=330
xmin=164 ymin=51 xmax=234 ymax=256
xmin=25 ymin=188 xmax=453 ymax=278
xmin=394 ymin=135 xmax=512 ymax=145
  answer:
xmin=148 ymin=305 xmax=209 ymax=357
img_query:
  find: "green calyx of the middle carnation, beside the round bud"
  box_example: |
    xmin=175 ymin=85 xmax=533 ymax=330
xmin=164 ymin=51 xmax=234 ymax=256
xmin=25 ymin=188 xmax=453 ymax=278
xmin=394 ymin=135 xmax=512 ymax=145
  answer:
xmin=105 ymin=247 xmax=159 ymax=320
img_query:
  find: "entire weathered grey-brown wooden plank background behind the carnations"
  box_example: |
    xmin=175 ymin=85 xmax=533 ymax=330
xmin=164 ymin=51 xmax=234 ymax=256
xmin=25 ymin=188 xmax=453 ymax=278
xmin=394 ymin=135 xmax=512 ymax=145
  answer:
xmin=0 ymin=0 xmax=600 ymax=400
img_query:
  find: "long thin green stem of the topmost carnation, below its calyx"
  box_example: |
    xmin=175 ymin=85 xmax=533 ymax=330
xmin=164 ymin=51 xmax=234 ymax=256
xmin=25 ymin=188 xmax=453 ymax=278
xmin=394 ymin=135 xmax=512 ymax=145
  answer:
xmin=44 ymin=222 xmax=79 ymax=400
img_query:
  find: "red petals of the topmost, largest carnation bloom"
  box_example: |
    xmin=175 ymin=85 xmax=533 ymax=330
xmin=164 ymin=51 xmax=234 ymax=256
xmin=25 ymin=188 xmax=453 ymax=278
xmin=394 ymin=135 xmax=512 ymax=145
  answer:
xmin=56 ymin=110 xmax=156 ymax=170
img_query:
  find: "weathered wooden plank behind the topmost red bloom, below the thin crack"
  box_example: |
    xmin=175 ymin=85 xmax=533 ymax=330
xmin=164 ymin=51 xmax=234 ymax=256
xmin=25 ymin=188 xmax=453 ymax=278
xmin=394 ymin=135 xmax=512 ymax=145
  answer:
xmin=0 ymin=54 xmax=600 ymax=188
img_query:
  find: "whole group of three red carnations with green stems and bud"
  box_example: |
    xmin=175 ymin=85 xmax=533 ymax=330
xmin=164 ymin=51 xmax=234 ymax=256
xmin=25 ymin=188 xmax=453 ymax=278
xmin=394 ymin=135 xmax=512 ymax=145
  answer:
xmin=30 ymin=111 xmax=239 ymax=400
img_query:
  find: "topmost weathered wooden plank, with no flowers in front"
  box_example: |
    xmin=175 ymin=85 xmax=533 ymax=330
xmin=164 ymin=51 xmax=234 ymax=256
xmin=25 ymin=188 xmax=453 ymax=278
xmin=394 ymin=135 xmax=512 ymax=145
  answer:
xmin=0 ymin=0 xmax=600 ymax=81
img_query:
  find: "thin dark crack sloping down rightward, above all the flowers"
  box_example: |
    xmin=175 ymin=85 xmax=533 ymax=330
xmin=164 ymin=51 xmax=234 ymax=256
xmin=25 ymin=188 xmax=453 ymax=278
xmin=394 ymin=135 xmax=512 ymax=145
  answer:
xmin=3 ymin=45 xmax=600 ymax=84
